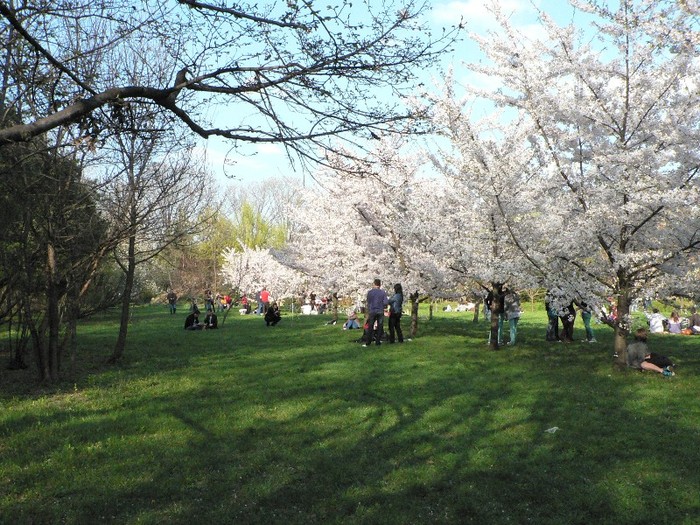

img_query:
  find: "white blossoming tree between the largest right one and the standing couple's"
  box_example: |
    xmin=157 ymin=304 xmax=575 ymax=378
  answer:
xmin=427 ymin=73 xmax=554 ymax=350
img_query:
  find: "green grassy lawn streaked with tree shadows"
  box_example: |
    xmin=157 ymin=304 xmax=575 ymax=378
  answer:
xmin=0 ymin=307 xmax=700 ymax=525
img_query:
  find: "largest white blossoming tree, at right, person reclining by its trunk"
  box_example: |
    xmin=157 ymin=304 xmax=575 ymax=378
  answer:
xmin=426 ymin=0 xmax=700 ymax=358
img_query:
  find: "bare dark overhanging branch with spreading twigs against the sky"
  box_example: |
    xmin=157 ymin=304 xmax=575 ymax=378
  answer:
xmin=0 ymin=0 xmax=461 ymax=160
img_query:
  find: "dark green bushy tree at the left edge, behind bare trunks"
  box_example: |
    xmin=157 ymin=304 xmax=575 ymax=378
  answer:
xmin=0 ymin=122 xmax=112 ymax=374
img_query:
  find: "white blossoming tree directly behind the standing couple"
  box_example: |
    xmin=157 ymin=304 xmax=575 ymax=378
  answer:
xmin=276 ymin=136 xmax=474 ymax=335
